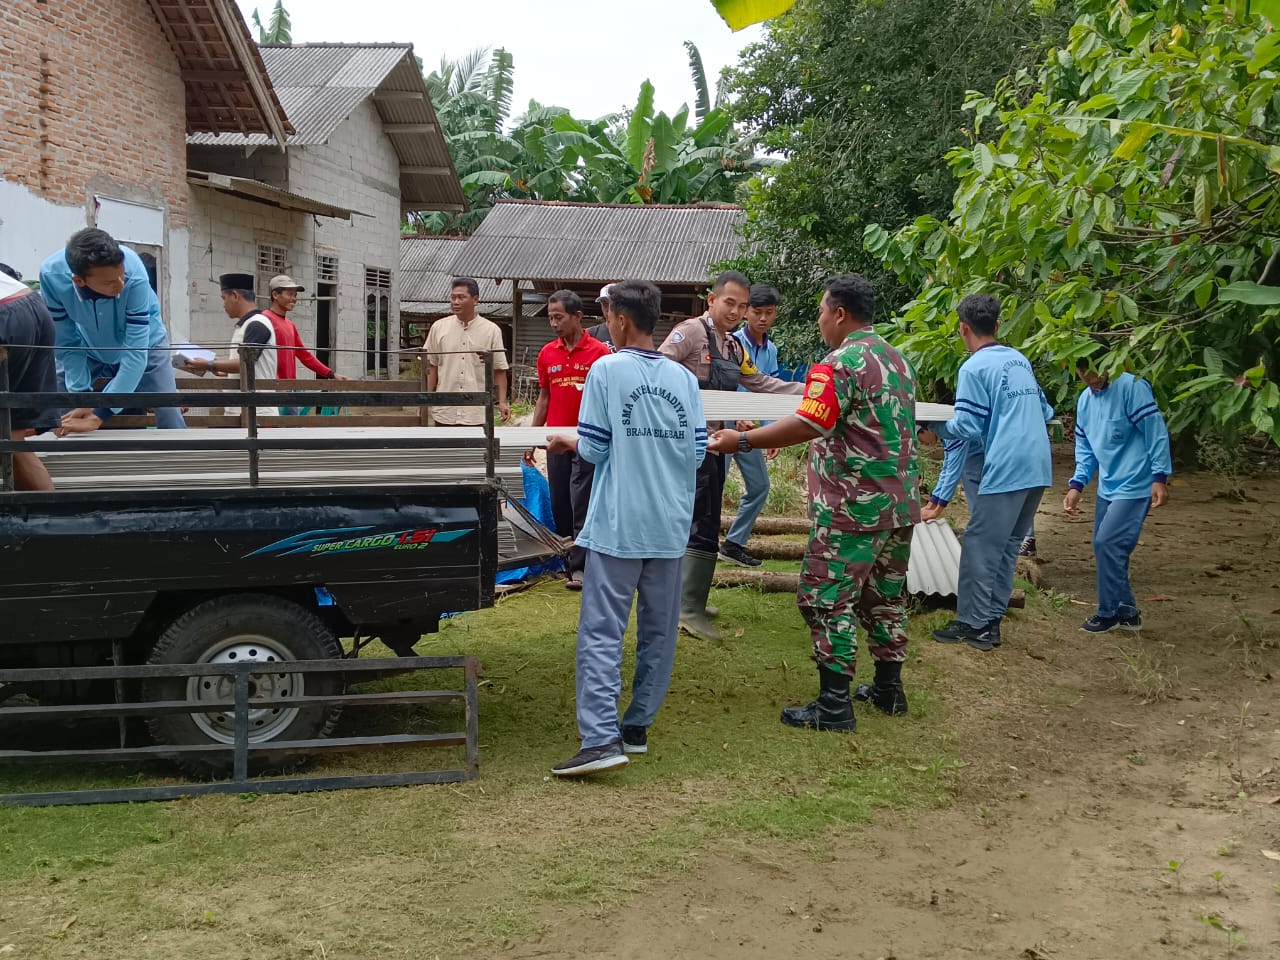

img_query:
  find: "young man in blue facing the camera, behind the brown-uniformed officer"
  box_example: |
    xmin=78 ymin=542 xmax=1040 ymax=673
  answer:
xmin=719 ymin=283 xmax=782 ymax=567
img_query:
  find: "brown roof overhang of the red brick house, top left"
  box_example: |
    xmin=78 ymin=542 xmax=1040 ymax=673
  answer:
xmin=148 ymin=0 xmax=293 ymax=145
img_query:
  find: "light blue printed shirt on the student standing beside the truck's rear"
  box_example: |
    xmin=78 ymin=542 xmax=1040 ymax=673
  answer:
xmin=576 ymin=347 xmax=707 ymax=559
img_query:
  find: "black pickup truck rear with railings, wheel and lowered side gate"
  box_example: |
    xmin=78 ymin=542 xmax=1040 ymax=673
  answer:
xmin=0 ymin=355 xmax=545 ymax=803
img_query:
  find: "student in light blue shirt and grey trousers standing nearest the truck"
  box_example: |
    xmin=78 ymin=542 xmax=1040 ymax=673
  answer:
xmin=547 ymin=280 xmax=707 ymax=777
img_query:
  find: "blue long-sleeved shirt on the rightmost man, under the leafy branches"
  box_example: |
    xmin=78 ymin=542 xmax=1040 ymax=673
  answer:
xmin=1070 ymin=374 xmax=1174 ymax=500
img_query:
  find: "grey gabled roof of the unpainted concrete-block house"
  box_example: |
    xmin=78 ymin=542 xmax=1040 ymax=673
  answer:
xmin=187 ymin=44 xmax=466 ymax=211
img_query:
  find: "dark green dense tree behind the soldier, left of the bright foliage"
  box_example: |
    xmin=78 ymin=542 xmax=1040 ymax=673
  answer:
xmin=726 ymin=0 xmax=1074 ymax=352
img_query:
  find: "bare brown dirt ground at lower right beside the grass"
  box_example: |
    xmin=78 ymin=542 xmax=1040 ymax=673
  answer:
xmin=507 ymin=463 xmax=1280 ymax=960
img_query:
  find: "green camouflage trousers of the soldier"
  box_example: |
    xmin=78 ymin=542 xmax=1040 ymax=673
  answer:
xmin=796 ymin=526 xmax=914 ymax=677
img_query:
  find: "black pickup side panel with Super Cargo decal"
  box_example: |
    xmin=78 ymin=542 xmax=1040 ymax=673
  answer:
xmin=0 ymin=484 xmax=499 ymax=666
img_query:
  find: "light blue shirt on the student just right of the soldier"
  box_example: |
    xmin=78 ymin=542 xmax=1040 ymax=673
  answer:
xmin=931 ymin=343 xmax=1053 ymax=503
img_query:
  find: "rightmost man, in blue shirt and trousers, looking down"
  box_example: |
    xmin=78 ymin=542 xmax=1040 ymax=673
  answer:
xmin=1062 ymin=358 xmax=1174 ymax=634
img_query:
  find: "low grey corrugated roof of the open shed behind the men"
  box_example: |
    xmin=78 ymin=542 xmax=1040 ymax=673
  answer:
xmin=453 ymin=200 xmax=746 ymax=284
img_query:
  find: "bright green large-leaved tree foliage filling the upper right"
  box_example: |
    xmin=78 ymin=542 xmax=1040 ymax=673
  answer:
xmin=865 ymin=0 xmax=1280 ymax=443
